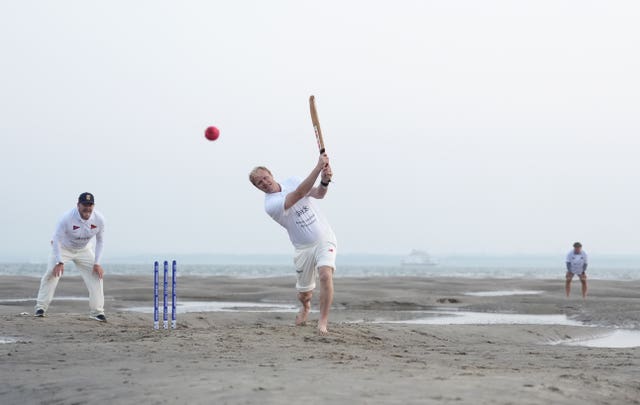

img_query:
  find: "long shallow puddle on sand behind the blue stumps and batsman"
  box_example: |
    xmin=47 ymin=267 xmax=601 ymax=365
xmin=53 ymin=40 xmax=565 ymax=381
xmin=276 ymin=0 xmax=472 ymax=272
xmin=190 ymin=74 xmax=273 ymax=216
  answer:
xmin=126 ymin=301 xmax=298 ymax=314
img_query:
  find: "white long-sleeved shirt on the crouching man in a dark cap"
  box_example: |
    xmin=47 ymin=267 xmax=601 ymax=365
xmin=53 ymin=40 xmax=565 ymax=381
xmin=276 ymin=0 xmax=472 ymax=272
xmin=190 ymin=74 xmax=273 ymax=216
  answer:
xmin=53 ymin=208 xmax=104 ymax=263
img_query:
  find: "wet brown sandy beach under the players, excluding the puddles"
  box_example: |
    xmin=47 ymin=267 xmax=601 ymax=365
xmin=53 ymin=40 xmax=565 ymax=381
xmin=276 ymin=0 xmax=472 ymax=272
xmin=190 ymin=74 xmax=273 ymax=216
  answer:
xmin=0 ymin=276 xmax=640 ymax=404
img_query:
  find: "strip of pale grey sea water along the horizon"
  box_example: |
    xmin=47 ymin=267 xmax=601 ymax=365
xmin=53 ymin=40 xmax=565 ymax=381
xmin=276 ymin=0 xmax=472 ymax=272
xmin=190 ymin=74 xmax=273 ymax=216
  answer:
xmin=0 ymin=255 xmax=640 ymax=280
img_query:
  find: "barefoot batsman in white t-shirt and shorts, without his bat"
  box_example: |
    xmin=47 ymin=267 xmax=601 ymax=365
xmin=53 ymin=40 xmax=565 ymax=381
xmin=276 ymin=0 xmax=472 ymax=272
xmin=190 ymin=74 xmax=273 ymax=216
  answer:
xmin=249 ymin=154 xmax=337 ymax=334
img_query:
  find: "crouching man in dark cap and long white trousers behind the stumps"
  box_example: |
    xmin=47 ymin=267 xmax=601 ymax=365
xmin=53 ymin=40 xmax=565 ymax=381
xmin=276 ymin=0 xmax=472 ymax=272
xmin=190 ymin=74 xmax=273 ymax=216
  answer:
xmin=35 ymin=193 xmax=107 ymax=322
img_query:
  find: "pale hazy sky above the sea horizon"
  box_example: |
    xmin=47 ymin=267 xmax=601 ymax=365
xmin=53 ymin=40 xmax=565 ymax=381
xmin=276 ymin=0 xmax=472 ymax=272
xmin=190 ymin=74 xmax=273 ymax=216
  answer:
xmin=0 ymin=0 xmax=640 ymax=260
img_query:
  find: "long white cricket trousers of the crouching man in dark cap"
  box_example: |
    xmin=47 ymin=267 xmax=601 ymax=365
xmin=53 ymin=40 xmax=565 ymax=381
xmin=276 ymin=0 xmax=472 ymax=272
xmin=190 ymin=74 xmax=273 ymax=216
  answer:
xmin=36 ymin=245 xmax=104 ymax=316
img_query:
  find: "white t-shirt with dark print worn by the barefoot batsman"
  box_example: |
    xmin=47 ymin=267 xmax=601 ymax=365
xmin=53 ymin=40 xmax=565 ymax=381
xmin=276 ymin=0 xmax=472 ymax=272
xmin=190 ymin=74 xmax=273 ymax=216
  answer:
xmin=264 ymin=178 xmax=333 ymax=248
